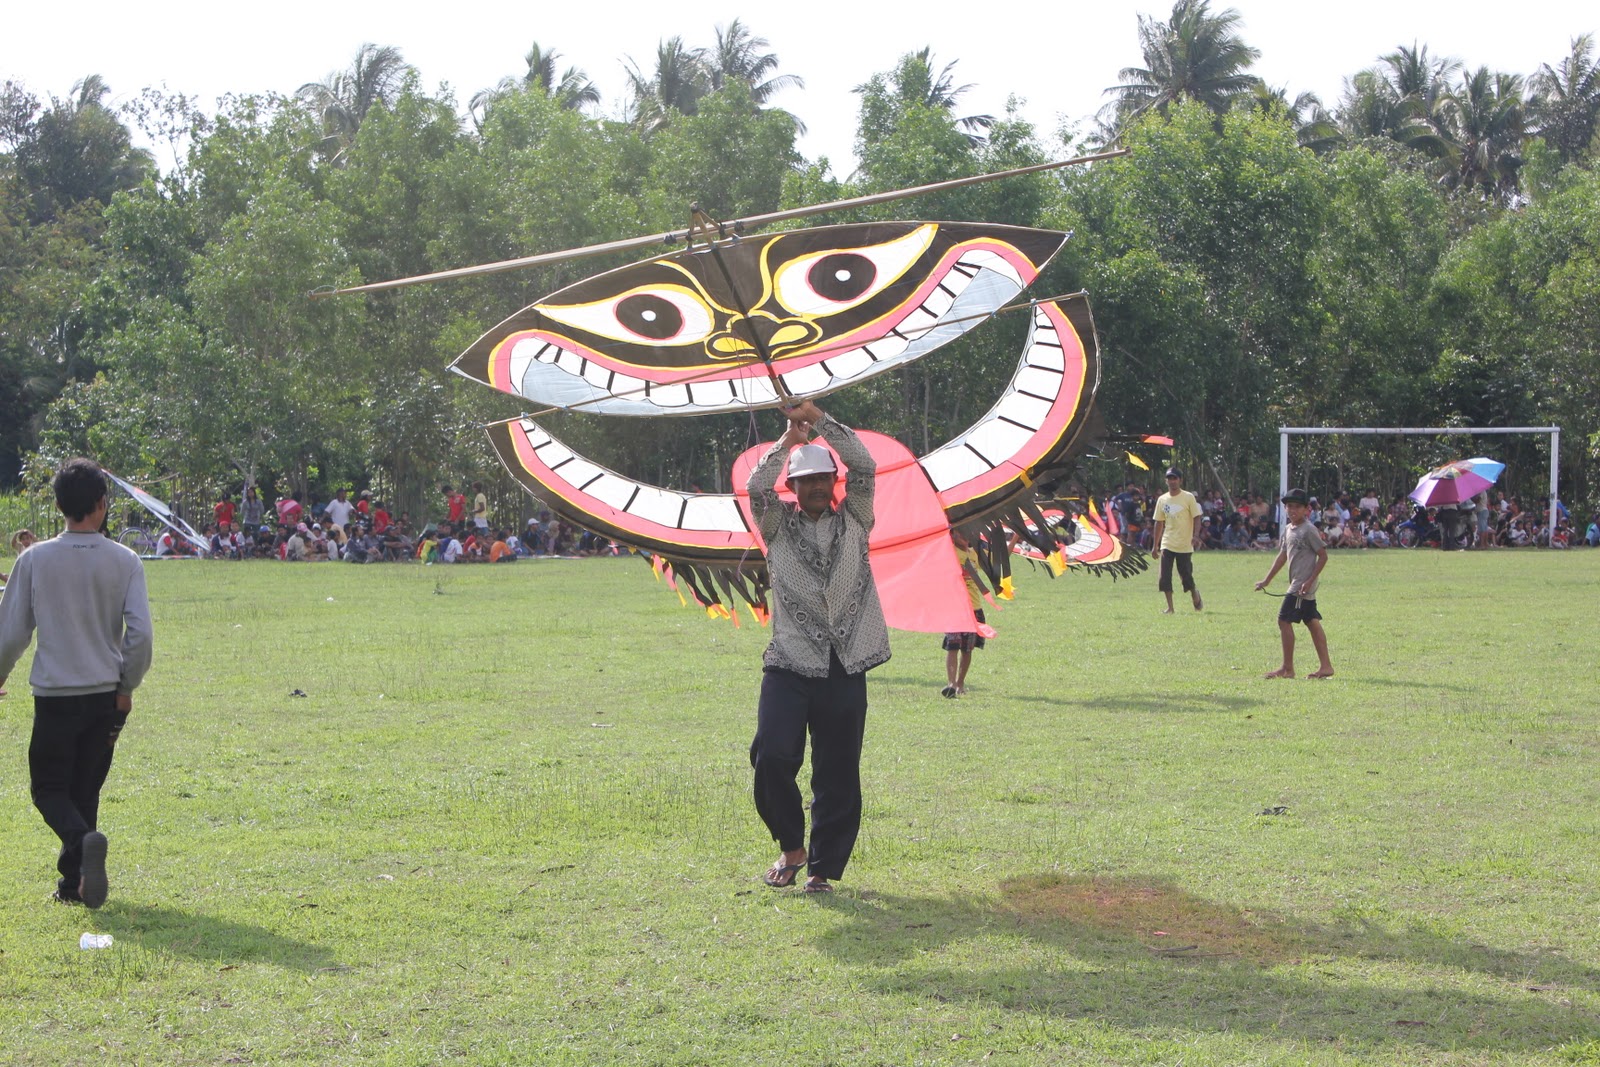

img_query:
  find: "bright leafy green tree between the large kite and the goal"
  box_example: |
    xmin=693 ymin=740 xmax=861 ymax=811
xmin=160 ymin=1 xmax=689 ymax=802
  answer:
xmin=1053 ymin=102 xmax=1330 ymax=495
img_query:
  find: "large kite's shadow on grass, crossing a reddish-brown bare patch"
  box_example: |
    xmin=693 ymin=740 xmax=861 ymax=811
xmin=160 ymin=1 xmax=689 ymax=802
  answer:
xmin=818 ymin=875 xmax=1600 ymax=1051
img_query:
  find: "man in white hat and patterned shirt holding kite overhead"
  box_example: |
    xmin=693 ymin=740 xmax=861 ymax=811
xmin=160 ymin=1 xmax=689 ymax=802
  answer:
xmin=749 ymin=400 xmax=890 ymax=893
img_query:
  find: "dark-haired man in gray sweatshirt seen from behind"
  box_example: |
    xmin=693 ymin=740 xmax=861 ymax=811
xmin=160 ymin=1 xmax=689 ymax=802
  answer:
xmin=0 ymin=459 xmax=152 ymax=907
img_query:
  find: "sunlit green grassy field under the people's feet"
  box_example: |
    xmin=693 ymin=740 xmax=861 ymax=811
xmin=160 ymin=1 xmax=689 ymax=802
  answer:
xmin=0 ymin=550 xmax=1600 ymax=1065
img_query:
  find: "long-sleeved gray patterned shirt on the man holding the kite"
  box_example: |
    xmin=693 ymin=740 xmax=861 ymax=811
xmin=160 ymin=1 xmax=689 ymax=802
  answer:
xmin=749 ymin=414 xmax=890 ymax=678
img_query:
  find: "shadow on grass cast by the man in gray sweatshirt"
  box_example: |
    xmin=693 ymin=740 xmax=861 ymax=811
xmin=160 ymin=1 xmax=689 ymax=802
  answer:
xmin=96 ymin=901 xmax=334 ymax=971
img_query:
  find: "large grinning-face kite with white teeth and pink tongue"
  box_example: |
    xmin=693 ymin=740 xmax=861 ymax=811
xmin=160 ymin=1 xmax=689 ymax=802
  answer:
xmin=324 ymin=156 xmax=1146 ymax=632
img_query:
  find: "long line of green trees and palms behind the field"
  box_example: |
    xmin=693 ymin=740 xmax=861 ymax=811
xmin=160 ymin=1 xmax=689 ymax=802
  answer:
xmin=0 ymin=0 xmax=1600 ymax=512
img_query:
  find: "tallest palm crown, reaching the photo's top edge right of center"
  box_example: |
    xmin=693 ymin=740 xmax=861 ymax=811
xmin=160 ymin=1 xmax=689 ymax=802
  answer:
xmin=1106 ymin=0 xmax=1261 ymax=126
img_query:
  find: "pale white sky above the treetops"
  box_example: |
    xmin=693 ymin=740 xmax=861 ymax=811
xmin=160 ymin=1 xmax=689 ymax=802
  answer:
xmin=0 ymin=0 xmax=1600 ymax=174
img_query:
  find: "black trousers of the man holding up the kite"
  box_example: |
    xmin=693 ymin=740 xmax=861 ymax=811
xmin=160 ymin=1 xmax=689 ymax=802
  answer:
xmin=750 ymin=656 xmax=867 ymax=880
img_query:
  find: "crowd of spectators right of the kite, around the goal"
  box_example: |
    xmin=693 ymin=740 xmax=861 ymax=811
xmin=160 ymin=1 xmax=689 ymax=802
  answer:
xmin=1107 ymin=482 xmax=1600 ymax=552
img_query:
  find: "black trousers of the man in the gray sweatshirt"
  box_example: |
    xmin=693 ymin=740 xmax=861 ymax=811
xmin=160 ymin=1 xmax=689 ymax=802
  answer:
xmin=27 ymin=691 xmax=128 ymax=896
